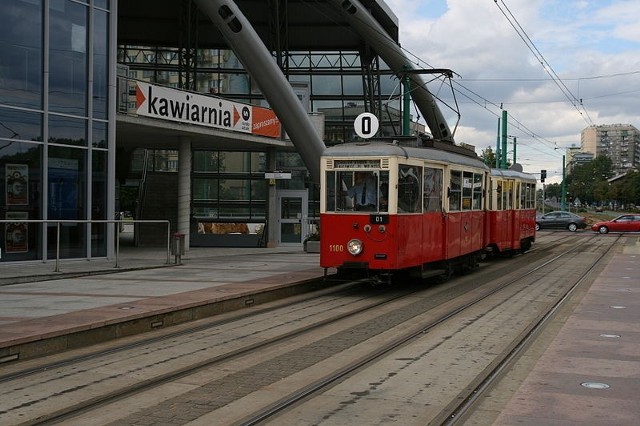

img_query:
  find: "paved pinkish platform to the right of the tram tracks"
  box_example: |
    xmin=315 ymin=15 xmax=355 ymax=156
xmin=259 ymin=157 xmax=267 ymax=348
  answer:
xmin=486 ymin=234 xmax=640 ymax=426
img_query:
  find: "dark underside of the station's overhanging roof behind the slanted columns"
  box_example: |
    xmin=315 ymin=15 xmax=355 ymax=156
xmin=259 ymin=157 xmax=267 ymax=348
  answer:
xmin=118 ymin=0 xmax=398 ymax=51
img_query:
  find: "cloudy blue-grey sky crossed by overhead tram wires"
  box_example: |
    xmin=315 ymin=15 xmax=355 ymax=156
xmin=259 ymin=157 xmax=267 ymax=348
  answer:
xmin=385 ymin=0 xmax=640 ymax=183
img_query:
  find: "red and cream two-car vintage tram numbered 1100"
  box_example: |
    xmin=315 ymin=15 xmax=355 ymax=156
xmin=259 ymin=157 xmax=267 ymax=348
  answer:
xmin=320 ymin=141 xmax=535 ymax=281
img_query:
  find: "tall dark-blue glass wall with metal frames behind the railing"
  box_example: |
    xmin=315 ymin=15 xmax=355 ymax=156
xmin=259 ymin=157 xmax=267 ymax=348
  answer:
xmin=0 ymin=0 xmax=114 ymax=261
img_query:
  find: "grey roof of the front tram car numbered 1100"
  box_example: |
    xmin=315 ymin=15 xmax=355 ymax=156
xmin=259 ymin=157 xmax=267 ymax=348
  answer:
xmin=323 ymin=142 xmax=488 ymax=169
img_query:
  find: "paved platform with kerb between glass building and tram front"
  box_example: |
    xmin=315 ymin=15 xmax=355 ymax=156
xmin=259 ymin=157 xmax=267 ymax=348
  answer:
xmin=0 ymin=247 xmax=324 ymax=366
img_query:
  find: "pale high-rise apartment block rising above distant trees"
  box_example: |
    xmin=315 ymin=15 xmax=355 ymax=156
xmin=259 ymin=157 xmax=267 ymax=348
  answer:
xmin=580 ymin=124 xmax=640 ymax=174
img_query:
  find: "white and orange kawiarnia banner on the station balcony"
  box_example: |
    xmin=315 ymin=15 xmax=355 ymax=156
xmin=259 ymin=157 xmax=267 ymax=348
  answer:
xmin=136 ymin=81 xmax=281 ymax=137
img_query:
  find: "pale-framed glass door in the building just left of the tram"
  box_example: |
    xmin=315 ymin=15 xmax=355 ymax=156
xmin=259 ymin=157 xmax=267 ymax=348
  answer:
xmin=278 ymin=190 xmax=309 ymax=246
